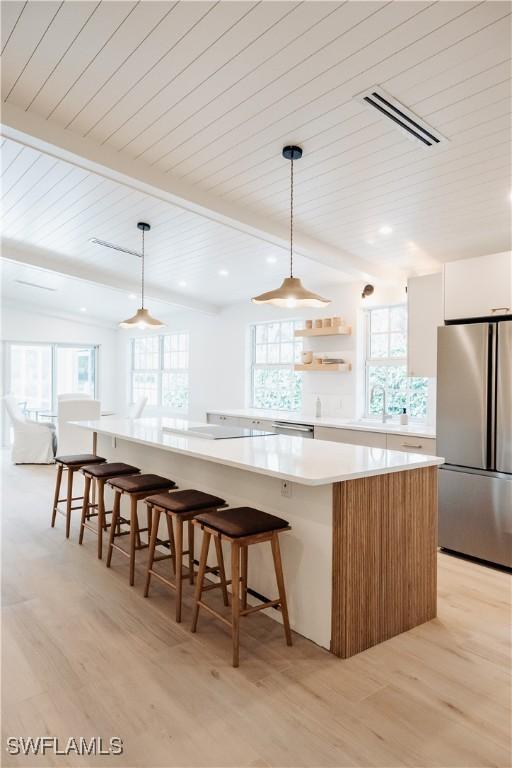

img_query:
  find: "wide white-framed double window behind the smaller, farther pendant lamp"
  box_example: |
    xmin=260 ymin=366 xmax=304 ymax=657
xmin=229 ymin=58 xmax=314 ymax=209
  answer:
xmin=131 ymin=332 xmax=189 ymax=412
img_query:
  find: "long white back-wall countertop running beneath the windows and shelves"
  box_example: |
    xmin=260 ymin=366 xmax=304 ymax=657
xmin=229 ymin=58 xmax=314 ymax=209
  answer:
xmin=207 ymin=408 xmax=436 ymax=440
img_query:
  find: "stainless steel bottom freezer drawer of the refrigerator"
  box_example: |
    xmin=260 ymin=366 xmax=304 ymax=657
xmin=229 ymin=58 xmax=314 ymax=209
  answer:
xmin=439 ymin=467 xmax=512 ymax=567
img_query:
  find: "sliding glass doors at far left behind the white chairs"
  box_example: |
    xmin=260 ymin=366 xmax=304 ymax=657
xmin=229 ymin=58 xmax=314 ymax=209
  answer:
xmin=7 ymin=342 xmax=98 ymax=411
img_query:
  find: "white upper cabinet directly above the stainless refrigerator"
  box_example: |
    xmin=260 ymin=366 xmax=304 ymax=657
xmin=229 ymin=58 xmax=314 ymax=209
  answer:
xmin=444 ymin=251 xmax=512 ymax=320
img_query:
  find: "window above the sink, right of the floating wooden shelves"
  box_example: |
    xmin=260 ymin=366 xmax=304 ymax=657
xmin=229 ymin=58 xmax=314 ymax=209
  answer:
xmin=366 ymin=304 xmax=428 ymax=421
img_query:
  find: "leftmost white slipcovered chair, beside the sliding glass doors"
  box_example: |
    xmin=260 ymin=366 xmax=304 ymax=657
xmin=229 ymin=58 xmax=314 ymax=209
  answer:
xmin=3 ymin=395 xmax=57 ymax=464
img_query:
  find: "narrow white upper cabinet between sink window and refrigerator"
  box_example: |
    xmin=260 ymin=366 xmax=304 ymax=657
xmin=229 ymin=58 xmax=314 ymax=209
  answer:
xmin=407 ymin=272 xmax=443 ymax=378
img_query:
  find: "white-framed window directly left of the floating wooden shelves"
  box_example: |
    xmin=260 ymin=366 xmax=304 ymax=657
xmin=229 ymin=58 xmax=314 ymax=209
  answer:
xmin=251 ymin=320 xmax=302 ymax=411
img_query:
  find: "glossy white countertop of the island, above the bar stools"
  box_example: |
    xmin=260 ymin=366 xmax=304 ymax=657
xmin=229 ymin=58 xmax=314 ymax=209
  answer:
xmin=72 ymin=416 xmax=444 ymax=485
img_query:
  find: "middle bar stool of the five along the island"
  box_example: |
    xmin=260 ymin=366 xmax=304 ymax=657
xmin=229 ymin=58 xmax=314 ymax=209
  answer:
xmin=107 ymin=475 xmax=176 ymax=586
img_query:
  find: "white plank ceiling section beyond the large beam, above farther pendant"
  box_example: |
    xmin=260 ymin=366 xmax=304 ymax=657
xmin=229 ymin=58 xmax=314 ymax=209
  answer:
xmin=0 ymin=139 xmax=350 ymax=306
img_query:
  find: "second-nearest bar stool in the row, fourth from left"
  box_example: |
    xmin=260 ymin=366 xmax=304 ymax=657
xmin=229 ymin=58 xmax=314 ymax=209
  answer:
xmin=144 ymin=489 xmax=229 ymax=623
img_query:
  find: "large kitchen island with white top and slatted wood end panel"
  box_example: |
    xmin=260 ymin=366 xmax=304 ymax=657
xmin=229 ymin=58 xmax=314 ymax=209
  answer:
xmin=75 ymin=417 xmax=443 ymax=658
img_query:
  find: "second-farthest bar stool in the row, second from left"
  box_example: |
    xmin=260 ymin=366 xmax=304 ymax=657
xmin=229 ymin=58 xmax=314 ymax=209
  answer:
xmin=78 ymin=461 xmax=140 ymax=560
